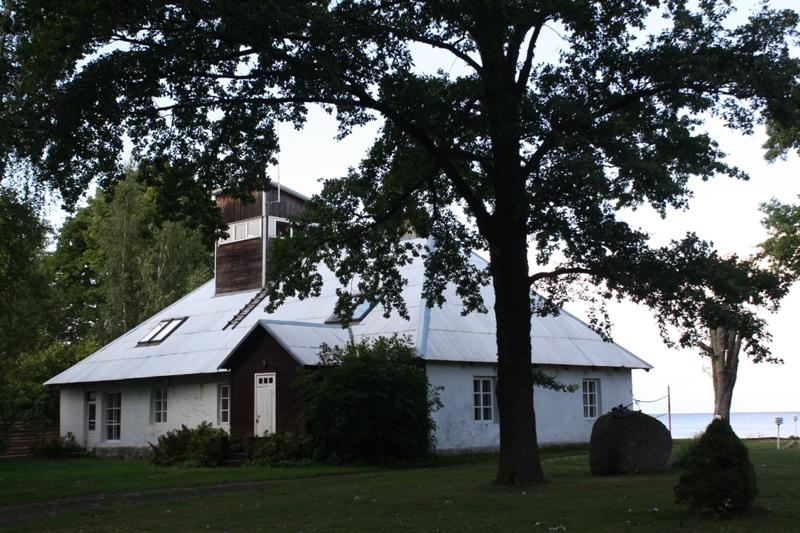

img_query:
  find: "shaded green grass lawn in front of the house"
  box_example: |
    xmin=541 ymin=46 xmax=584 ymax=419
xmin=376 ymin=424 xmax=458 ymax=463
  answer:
xmin=0 ymin=441 xmax=800 ymax=533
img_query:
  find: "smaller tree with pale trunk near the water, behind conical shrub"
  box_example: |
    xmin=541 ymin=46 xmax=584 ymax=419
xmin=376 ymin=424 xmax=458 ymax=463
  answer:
xmin=628 ymin=236 xmax=796 ymax=420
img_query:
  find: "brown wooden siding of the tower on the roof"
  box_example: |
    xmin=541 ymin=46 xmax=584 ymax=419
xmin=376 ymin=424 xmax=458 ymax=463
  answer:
xmin=215 ymin=188 xmax=305 ymax=294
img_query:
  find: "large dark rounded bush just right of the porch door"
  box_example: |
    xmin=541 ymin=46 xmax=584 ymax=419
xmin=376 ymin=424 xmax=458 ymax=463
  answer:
xmin=293 ymin=336 xmax=440 ymax=464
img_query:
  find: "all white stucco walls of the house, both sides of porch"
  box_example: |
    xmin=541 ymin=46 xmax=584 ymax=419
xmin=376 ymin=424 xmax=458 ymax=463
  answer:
xmin=53 ymin=361 xmax=632 ymax=453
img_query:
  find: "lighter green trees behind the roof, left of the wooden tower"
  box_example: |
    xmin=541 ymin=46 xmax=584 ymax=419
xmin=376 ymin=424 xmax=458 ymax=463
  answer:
xmin=50 ymin=169 xmax=215 ymax=343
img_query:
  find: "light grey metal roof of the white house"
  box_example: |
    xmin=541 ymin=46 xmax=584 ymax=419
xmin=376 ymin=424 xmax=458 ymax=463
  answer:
xmin=46 ymin=239 xmax=652 ymax=385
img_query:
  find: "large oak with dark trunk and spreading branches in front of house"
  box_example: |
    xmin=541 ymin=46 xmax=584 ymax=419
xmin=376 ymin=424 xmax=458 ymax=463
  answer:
xmin=0 ymin=0 xmax=798 ymax=483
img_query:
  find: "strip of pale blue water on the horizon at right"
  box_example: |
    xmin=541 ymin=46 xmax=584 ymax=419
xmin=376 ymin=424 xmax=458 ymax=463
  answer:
xmin=650 ymin=411 xmax=800 ymax=439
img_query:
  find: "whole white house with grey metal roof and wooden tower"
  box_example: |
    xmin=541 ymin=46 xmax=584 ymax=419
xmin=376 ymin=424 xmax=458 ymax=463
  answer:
xmin=47 ymin=185 xmax=651 ymax=455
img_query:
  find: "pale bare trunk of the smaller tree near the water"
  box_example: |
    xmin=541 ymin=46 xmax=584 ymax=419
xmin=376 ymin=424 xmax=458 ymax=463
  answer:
xmin=709 ymin=328 xmax=742 ymax=421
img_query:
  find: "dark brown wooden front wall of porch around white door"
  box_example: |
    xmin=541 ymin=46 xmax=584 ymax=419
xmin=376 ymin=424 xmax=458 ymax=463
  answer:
xmin=225 ymin=328 xmax=300 ymax=437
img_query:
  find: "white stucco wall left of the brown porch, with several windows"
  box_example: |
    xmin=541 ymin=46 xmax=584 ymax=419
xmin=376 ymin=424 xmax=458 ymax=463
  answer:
xmin=56 ymin=373 xmax=230 ymax=452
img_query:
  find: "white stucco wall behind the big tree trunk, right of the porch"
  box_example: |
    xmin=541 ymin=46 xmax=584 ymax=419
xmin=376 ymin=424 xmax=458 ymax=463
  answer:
xmin=427 ymin=361 xmax=632 ymax=452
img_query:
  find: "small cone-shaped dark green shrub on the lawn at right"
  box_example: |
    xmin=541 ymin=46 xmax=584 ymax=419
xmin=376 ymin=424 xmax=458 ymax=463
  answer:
xmin=675 ymin=419 xmax=758 ymax=514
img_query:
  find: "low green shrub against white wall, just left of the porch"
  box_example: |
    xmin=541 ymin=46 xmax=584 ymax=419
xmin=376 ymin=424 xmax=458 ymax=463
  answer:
xmin=150 ymin=422 xmax=227 ymax=467
